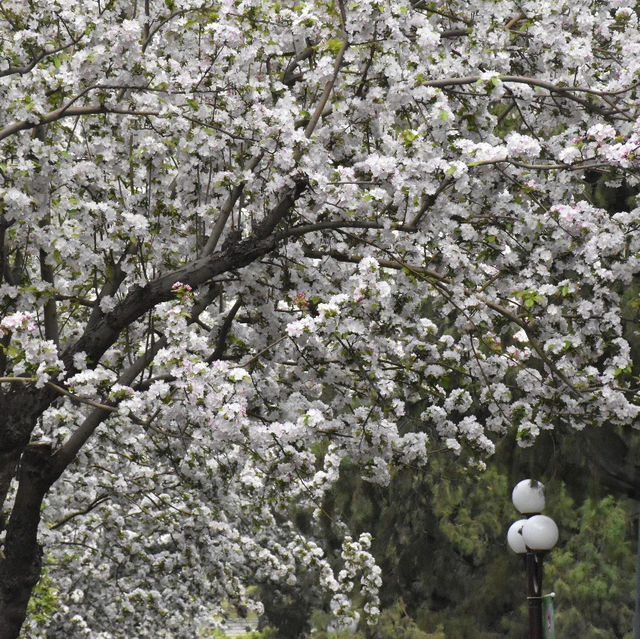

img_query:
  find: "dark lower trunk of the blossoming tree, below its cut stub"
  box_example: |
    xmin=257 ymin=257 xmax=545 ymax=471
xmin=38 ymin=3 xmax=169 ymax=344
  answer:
xmin=0 ymin=445 xmax=51 ymax=639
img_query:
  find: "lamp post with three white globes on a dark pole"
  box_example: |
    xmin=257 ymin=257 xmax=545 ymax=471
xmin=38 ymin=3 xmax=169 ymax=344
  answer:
xmin=507 ymin=479 xmax=558 ymax=639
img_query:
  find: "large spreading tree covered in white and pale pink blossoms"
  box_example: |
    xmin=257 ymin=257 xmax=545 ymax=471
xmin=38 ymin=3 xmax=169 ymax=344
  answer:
xmin=0 ymin=0 xmax=640 ymax=639
